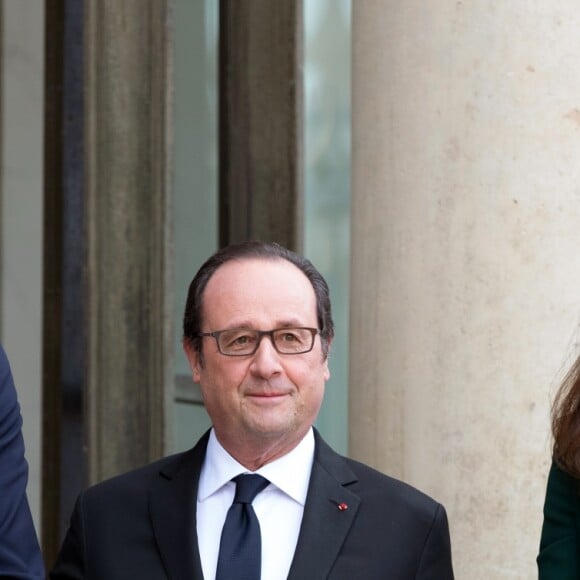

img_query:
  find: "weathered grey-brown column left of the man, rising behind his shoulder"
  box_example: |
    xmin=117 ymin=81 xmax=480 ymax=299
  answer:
xmin=85 ymin=0 xmax=171 ymax=482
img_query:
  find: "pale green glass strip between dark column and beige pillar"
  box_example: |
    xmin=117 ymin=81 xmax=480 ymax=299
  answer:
xmin=304 ymin=0 xmax=350 ymax=453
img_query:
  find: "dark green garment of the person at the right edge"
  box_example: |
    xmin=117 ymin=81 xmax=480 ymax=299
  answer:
xmin=537 ymin=464 xmax=580 ymax=580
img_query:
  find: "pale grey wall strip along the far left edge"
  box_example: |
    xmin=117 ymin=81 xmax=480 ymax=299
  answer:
xmin=0 ymin=0 xmax=44 ymax=532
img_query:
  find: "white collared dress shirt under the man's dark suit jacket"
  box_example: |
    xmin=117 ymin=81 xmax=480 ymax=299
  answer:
xmin=197 ymin=428 xmax=314 ymax=580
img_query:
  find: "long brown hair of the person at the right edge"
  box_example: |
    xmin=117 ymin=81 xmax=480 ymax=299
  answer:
xmin=552 ymin=356 xmax=580 ymax=479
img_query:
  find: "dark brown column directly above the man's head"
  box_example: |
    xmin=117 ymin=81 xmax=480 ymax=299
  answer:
xmin=219 ymin=0 xmax=303 ymax=250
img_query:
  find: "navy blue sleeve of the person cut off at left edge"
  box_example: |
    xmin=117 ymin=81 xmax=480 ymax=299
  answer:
xmin=0 ymin=346 xmax=45 ymax=580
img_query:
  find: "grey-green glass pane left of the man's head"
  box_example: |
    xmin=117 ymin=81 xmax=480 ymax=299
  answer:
xmin=171 ymin=0 xmax=218 ymax=451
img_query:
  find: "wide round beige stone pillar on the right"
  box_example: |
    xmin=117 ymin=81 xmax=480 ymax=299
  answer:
xmin=350 ymin=0 xmax=580 ymax=580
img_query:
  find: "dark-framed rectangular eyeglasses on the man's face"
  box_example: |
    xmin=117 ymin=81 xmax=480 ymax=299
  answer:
xmin=198 ymin=326 xmax=319 ymax=356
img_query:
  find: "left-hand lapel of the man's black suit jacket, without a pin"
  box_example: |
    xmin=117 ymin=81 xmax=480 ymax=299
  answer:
xmin=149 ymin=433 xmax=208 ymax=580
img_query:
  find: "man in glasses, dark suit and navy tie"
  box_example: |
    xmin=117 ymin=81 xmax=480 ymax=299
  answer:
xmin=51 ymin=242 xmax=453 ymax=580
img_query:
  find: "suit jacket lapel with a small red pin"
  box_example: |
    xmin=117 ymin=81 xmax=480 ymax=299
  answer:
xmin=288 ymin=431 xmax=360 ymax=580
